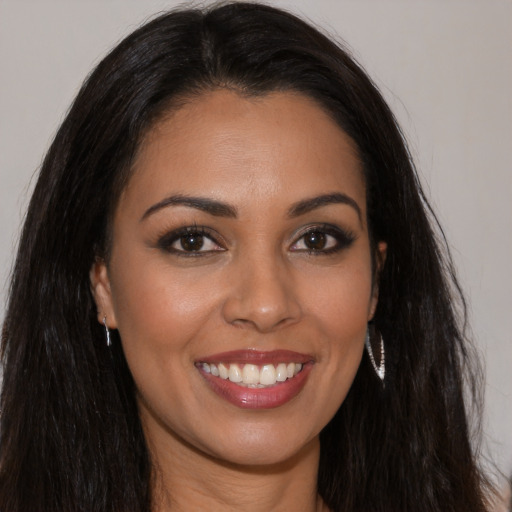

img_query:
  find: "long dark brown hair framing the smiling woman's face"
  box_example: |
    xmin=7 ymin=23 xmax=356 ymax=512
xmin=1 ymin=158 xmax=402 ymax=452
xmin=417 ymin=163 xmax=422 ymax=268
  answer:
xmin=0 ymin=3 xmax=486 ymax=512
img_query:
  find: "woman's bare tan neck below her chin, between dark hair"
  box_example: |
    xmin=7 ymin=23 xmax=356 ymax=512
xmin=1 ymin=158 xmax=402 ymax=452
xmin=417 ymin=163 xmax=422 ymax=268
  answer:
xmin=146 ymin=424 xmax=327 ymax=512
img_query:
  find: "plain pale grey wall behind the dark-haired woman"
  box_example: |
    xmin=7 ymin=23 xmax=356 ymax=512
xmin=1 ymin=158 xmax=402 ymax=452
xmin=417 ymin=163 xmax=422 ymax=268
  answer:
xmin=0 ymin=0 xmax=512 ymax=484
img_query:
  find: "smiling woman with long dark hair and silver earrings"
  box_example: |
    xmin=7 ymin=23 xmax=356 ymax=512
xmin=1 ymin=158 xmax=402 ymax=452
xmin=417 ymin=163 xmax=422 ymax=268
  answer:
xmin=0 ymin=3 xmax=494 ymax=512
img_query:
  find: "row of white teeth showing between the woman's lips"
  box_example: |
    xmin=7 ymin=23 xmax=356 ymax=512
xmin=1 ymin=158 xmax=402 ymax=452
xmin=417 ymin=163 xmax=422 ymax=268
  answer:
xmin=197 ymin=362 xmax=303 ymax=389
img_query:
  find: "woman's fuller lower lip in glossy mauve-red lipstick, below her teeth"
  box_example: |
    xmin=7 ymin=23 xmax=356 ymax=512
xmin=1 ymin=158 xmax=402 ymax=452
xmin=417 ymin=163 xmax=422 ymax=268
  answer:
xmin=200 ymin=363 xmax=313 ymax=409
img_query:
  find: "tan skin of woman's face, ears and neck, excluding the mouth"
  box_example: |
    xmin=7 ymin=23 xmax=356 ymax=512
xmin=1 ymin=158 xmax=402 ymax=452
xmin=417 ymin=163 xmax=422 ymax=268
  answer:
xmin=91 ymin=90 xmax=386 ymax=512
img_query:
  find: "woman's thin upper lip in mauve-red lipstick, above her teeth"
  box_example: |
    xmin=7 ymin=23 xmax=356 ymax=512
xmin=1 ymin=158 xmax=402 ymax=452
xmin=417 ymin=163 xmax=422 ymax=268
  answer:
xmin=196 ymin=349 xmax=314 ymax=365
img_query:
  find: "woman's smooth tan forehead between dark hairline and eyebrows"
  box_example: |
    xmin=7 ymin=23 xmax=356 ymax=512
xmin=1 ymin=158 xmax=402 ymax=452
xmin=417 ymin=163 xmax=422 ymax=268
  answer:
xmin=121 ymin=90 xmax=365 ymax=218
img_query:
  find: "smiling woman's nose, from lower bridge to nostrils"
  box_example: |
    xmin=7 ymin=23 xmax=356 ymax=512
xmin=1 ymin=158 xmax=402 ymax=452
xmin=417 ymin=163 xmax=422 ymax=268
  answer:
xmin=223 ymin=257 xmax=301 ymax=333
